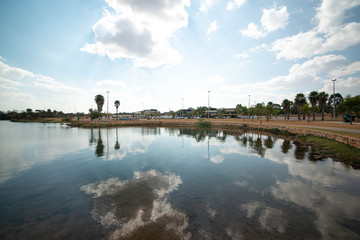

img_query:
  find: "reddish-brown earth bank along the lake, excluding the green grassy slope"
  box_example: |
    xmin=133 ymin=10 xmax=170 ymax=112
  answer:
xmin=10 ymin=118 xmax=360 ymax=149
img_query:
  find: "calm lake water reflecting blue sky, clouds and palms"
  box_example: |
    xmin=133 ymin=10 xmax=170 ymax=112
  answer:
xmin=0 ymin=121 xmax=360 ymax=239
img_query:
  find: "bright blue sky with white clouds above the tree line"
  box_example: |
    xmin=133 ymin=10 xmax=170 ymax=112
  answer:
xmin=0 ymin=0 xmax=360 ymax=113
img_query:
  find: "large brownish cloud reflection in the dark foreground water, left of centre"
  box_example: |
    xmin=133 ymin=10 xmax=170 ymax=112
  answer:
xmin=80 ymin=170 xmax=191 ymax=239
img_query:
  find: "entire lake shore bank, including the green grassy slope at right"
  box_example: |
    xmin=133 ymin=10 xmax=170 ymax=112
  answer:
xmin=7 ymin=118 xmax=360 ymax=169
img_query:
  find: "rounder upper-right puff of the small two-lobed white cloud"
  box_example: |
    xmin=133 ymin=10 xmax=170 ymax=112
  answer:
xmin=261 ymin=6 xmax=289 ymax=32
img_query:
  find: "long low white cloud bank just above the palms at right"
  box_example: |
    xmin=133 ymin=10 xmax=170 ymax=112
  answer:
xmin=221 ymin=54 xmax=360 ymax=102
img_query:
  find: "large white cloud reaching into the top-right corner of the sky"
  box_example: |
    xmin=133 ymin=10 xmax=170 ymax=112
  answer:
xmin=272 ymin=0 xmax=360 ymax=60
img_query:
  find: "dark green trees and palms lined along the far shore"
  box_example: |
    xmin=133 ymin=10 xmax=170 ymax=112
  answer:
xmin=0 ymin=91 xmax=360 ymax=123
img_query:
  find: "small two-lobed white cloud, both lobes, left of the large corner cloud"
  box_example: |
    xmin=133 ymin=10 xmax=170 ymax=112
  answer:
xmin=240 ymin=6 xmax=289 ymax=39
